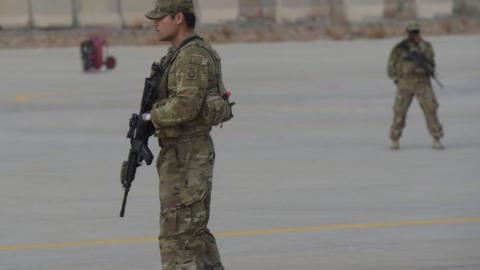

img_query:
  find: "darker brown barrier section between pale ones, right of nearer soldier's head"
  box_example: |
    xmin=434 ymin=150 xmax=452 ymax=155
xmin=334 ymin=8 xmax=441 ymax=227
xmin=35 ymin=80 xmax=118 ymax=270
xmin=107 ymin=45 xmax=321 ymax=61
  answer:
xmin=238 ymin=0 xmax=277 ymax=21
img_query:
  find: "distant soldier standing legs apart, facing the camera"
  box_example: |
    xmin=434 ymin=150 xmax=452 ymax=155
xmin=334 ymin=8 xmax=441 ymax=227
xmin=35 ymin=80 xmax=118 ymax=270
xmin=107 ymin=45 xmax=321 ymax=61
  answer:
xmin=388 ymin=22 xmax=443 ymax=150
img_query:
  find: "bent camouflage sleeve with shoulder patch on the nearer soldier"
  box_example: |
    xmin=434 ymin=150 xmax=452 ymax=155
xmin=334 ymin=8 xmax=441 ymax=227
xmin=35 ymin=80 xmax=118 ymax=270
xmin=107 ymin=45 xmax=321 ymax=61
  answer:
xmin=150 ymin=54 xmax=208 ymax=127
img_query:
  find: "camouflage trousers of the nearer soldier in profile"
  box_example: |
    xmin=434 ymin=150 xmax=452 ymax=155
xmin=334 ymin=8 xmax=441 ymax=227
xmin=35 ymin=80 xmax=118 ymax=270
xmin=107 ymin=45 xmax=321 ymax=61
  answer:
xmin=157 ymin=138 xmax=223 ymax=270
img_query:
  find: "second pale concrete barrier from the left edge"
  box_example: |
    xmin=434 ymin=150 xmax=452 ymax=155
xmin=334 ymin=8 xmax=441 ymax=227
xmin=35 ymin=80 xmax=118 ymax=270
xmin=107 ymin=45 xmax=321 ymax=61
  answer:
xmin=30 ymin=0 xmax=73 ymax=28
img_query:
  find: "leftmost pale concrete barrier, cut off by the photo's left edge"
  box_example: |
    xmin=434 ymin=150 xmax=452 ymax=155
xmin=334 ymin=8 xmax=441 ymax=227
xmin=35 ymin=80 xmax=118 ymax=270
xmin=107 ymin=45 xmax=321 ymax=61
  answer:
xmin=0 ymin=0 xmax=29 ymax=28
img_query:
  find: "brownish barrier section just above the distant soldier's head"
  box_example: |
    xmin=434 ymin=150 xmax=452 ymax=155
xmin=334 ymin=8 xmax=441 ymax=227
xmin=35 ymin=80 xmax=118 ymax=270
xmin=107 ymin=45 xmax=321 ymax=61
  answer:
xmin=383 ymin=0 xmax=417 ymax=21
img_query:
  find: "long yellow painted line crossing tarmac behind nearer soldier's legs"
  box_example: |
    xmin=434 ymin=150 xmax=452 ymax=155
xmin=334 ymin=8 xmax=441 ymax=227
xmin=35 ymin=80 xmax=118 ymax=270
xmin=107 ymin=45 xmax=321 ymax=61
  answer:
xmin=0 ymin=217 xmax=480 ymax=251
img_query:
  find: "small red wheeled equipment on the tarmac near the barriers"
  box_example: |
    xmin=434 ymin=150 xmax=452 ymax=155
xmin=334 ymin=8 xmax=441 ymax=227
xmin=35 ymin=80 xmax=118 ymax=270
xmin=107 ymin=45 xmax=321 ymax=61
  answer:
xmin=80 ymin=36 xmax=117 ymax=72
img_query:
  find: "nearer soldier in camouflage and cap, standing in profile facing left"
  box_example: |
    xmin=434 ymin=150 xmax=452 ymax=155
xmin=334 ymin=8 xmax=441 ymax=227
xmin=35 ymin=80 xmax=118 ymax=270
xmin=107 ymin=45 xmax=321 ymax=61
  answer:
xmin=146 ymin=0 xmax=224 ymax=270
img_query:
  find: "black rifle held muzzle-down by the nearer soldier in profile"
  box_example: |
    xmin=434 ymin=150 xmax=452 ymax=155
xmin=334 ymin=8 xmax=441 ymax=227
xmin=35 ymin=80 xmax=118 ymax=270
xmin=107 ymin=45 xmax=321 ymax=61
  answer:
xmin=120 ymin=63 xmax=164 ymax=217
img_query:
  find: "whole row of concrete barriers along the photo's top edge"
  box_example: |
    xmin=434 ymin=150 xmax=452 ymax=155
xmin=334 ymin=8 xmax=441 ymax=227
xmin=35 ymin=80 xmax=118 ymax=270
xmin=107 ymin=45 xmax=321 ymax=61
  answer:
xmin=0 ymin=0 xmax=460 ymax=29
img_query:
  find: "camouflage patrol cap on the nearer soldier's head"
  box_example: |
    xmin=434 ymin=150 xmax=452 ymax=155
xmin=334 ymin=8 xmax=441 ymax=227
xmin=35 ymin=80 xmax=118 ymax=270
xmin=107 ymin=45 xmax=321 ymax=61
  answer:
xmin=145 ymin=0 xmax=195 ymax=20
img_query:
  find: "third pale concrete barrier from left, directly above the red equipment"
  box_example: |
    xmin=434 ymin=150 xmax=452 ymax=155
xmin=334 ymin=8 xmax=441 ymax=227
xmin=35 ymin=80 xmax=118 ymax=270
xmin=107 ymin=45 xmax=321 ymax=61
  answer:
xmin=75 ymin=0 xmax=122 ymax=27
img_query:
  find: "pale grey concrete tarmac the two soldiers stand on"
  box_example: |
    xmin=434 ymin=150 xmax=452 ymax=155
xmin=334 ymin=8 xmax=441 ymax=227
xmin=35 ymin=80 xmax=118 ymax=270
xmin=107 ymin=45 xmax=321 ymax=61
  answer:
xmin=0 ymin=36 xmax=480 ymax=270
